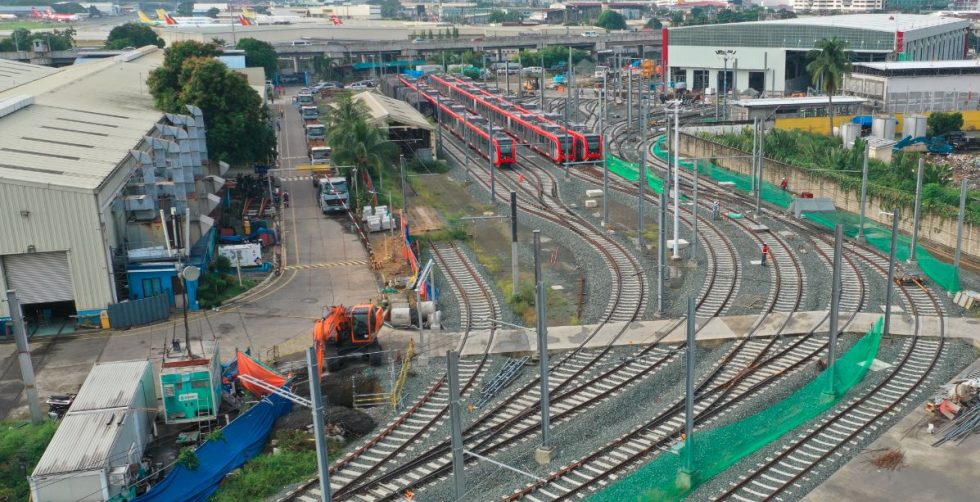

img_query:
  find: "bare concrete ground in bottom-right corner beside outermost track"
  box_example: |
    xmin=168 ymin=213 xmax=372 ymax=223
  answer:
xmin=803 ymin=361 xmax=980 ymax=502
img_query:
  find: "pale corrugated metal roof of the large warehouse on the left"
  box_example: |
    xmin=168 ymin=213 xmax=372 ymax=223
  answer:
xmin=0 ymin=49 xmax=163 ymax=191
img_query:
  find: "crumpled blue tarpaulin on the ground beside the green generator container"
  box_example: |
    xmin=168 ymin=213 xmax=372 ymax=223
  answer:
xmin=136 ymin=395 xmax=293 ymax=502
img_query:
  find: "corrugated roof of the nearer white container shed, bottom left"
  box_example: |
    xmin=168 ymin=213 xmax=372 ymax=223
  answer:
xmin=31 ymin=411 xmax=126 ymax=477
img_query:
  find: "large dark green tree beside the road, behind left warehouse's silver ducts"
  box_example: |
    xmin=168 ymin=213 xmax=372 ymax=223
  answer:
xmin=179 ymin=58 xmax=276 ymax=165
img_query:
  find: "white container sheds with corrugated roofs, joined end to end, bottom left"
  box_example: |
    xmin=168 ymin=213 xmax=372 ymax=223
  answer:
xmin=29 ymin=361 xmax=157 ymax=502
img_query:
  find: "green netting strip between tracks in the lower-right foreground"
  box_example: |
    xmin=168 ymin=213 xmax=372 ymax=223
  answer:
xmin=590 ymin=319 xmax=884 ymax=502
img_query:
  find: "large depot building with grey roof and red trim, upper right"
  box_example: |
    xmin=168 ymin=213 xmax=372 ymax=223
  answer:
xmin=663 ymin=14 xmax=970 ymax=97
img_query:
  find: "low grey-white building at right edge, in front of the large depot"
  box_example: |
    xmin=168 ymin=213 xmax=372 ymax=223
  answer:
xmin=843 ymin=59 xmax=980 ymax=113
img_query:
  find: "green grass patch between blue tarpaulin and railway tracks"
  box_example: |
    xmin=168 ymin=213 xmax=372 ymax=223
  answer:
xmin=211 ymin=430 xmax=342 ymax=502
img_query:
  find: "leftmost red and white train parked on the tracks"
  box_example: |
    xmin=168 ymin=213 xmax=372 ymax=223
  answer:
xmin=398 ymin=77 xmax=517 ymax=167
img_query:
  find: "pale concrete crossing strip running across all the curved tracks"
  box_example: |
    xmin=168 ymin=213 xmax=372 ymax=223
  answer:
xmin=396 ymin=311 xmax=980 ymax=356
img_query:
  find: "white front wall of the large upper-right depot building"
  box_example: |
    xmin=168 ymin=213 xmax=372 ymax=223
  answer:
xmin=667 ymin=45 xmax=786 ymax=94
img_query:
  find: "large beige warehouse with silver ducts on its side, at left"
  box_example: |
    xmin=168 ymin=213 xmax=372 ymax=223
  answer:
xmin=0 ymin=47 xmax=228 ymax=334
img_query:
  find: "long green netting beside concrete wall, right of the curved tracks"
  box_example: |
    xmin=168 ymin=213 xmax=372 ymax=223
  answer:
xmin=648 ymin=138 xmax=960 ymax=293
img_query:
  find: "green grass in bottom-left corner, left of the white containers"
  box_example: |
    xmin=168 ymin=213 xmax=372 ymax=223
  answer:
xmin=0 ymin=420 xmax=58 ymax=500
